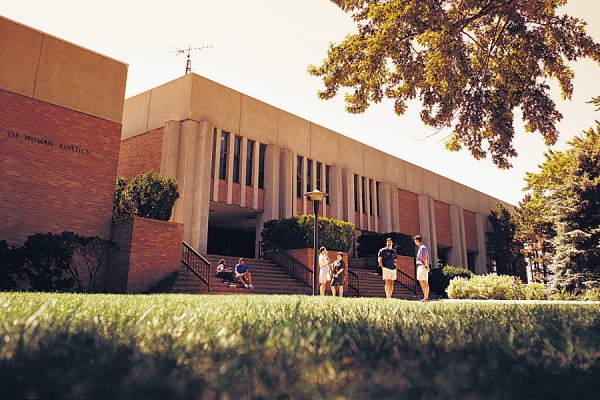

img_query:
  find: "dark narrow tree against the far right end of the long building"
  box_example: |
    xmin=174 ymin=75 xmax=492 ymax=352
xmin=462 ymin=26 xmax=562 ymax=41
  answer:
xmin=486 ymin=202 xmax=525 ymax=280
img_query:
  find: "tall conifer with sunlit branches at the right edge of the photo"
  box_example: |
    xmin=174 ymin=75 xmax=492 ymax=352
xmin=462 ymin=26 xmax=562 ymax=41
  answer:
xmin=549 ymin=123 xmax=600 ymax=293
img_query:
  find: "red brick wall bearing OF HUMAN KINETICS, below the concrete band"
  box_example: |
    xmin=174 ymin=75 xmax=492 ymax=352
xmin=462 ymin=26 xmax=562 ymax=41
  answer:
xmin=0 ymin=90 xmax=121 ymax=245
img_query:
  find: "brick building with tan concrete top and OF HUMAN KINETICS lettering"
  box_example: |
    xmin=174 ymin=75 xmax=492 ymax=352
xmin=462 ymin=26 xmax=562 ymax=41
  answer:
xmin=0 ymin=17 xmax=127 ymax=245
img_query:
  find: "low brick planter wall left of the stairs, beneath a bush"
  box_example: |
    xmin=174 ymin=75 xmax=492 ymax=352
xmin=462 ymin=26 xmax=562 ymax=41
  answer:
xmin=107 ymin=217 xmax=183 ymax=293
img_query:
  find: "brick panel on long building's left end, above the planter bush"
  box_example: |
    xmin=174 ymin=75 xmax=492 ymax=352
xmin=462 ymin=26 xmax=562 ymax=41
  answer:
xmin=117 ymin=127 xmax=164 ymax=178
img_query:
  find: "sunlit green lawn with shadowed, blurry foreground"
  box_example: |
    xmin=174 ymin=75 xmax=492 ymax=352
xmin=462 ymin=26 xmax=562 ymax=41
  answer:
xmin=0 ymin=293 xmax=600 ymax=400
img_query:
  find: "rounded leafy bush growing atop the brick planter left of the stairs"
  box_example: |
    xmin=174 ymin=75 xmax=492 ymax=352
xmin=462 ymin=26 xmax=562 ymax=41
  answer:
xmin=113 ymin=171 xmax=179 ymax=221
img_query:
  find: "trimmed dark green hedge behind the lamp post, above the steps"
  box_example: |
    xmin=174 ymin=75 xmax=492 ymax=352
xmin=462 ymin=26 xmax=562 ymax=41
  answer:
xmin=261 ymin=215 xmax=354 ymax=252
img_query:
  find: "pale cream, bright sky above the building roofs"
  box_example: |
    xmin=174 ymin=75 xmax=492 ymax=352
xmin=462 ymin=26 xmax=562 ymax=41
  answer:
xmin=0 ymin=0 xmax=600 ymax=205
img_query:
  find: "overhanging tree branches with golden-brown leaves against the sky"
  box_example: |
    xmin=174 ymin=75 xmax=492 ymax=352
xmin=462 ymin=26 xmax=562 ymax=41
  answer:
xmin=308 ymin=0 xmax=600 ymax=168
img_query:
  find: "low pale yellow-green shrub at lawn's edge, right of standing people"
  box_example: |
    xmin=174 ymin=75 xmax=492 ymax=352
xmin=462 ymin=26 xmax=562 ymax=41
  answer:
xmin=447 ymin=274 xmax=547 ymax=300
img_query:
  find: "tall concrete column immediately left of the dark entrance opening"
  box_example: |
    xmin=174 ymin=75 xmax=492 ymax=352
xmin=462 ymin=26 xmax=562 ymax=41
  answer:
xmin=189 ymin=121 xmax=214 ymax=253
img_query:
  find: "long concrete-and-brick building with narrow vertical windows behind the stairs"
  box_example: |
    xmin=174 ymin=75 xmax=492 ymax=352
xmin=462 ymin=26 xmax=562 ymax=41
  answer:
xmin=118 ymin=74 xmax=508 ymax=273
